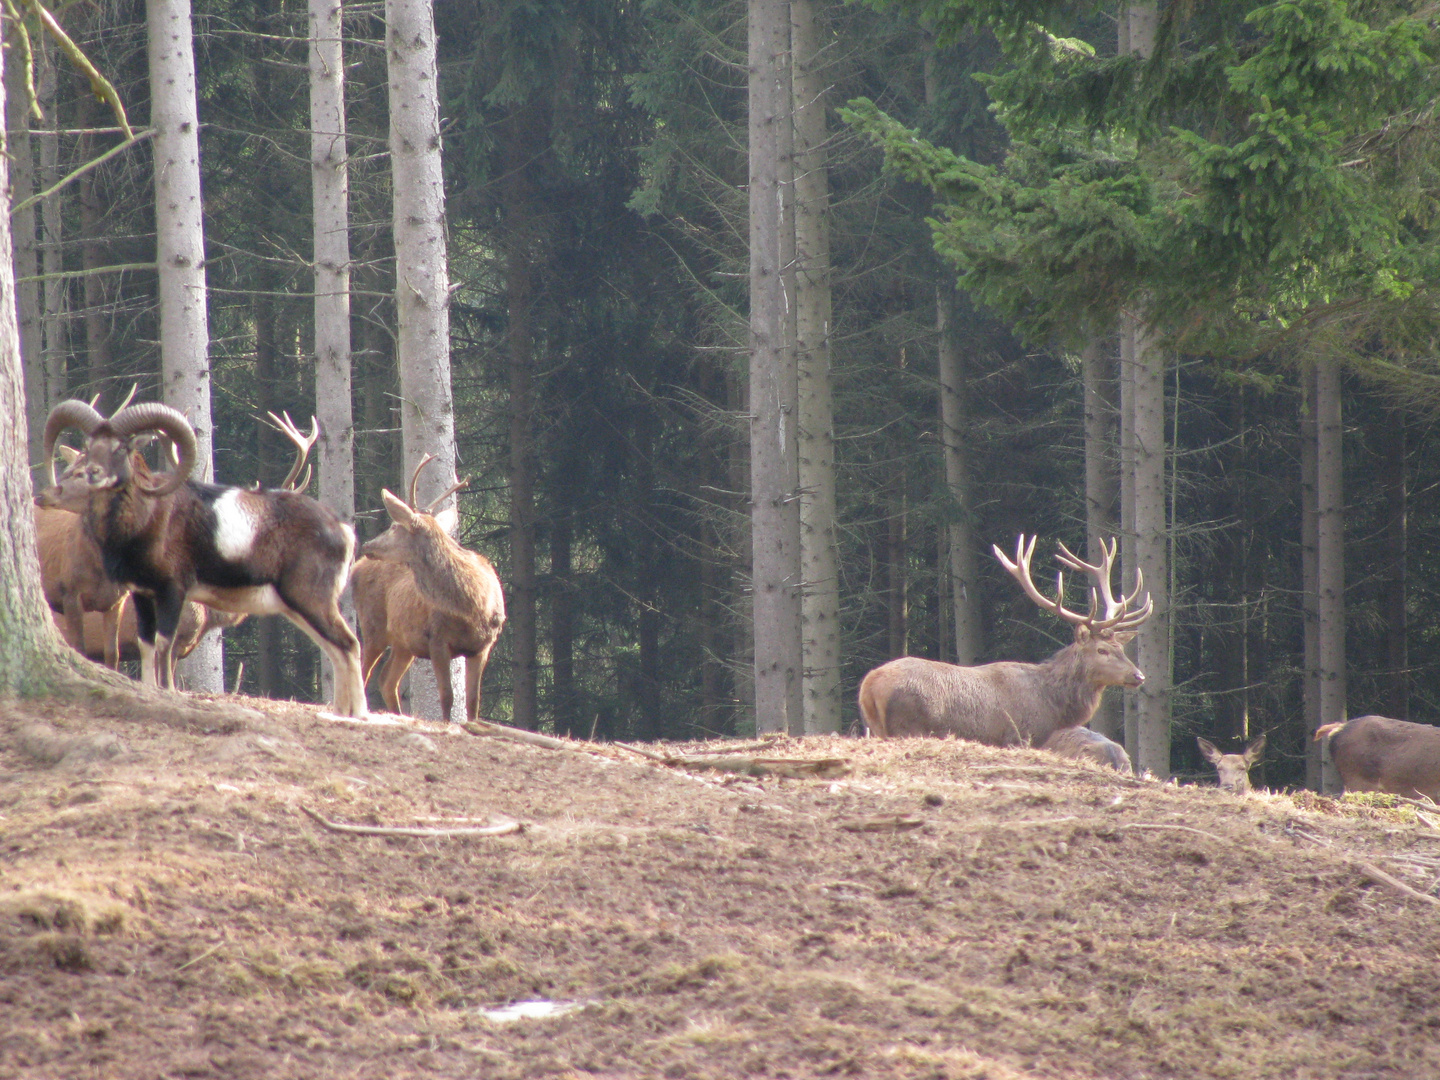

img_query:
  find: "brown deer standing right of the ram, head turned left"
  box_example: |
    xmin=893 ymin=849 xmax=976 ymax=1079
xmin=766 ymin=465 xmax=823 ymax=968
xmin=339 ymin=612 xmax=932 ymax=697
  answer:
xmin=351 ymin=455 xmax=505 ymax=720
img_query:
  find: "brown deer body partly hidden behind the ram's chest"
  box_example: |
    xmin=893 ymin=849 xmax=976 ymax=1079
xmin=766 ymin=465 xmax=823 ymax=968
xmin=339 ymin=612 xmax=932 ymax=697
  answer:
xmin=35 ymin=507 xmax=130 ymax=668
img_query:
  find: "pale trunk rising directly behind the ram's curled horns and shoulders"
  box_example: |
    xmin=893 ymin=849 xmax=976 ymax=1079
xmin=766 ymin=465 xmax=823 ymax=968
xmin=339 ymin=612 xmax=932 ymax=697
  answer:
xmin=147 ymin=0 xmax=225 ymax=693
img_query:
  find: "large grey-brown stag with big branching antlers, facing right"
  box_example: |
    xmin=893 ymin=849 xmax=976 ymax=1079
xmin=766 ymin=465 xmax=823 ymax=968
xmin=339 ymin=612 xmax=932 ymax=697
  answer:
xmin=860 ymin=534 xmax=1151 ymax=746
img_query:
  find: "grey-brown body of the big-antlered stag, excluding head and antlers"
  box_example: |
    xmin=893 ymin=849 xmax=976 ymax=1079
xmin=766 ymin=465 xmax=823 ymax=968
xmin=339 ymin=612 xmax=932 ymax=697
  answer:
xmin=860 ymin=656 xmax=1103 ymax=746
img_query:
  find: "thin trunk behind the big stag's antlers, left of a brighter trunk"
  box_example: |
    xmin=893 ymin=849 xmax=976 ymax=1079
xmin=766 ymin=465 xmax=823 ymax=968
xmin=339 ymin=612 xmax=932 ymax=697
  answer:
xmin=1080 ymin=340 xmax=1125 ymax=742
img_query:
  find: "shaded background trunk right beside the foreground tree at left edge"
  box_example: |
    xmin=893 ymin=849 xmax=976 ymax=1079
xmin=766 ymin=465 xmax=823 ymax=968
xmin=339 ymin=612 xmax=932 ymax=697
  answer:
xmin=4 ymin=40 xmax=41 ymax=462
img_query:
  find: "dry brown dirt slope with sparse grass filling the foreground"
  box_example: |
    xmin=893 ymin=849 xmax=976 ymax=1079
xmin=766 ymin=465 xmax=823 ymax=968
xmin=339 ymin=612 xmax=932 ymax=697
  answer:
xmin=0 ymin=700 xmax=1440 ymax=1080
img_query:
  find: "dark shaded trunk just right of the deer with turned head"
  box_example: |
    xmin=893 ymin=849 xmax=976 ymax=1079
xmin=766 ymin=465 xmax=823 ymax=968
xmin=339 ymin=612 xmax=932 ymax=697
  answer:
xmin=504 ymin=107 xmax=540 ymax=729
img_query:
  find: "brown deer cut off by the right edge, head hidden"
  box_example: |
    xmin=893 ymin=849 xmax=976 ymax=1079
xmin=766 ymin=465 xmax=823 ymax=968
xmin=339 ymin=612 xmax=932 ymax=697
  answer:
xmin=1315 ymin=716 xmax=1440 ymax=802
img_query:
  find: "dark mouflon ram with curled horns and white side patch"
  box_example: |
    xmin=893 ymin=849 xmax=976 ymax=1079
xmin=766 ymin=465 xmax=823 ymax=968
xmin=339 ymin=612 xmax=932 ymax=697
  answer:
xmin=45 ymin=400 xmax=366 ymax=716
